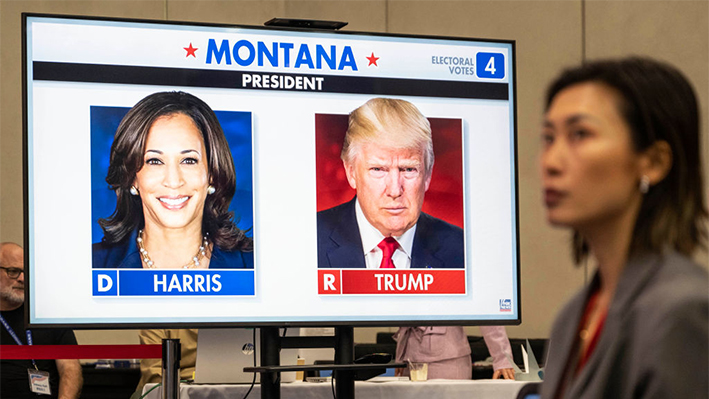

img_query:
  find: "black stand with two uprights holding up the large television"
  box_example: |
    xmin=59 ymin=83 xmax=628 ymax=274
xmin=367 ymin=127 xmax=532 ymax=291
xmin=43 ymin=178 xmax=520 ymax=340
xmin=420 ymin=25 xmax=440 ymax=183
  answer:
xmin=244 ymin=326 xmax=405 ymax=399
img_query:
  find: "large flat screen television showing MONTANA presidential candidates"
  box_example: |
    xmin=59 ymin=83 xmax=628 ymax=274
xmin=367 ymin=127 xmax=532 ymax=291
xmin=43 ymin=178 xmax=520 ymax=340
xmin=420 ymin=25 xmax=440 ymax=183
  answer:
xmin=23 ymin=14 xmax=521 ymax=328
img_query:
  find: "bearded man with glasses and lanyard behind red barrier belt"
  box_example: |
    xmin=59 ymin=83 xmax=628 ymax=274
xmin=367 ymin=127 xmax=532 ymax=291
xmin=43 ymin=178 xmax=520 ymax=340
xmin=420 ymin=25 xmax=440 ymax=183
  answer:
xmin=0 ymin=243 xmax=83 ymax=398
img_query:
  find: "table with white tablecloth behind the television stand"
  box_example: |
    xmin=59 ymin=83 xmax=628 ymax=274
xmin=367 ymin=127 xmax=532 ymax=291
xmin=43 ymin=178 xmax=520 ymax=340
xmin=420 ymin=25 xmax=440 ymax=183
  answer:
xmin=143 ymin=380 xmax=527 ymax=399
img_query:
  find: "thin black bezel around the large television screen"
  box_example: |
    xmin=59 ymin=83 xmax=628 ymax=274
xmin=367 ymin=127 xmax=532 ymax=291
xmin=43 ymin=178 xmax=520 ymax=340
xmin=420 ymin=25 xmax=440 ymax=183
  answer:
xmin=22 ymin=12 xmax=522 ymax=330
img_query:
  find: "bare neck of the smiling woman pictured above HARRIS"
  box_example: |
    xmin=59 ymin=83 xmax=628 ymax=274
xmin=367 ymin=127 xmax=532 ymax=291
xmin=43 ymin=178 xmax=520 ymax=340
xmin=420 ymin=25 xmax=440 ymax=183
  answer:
xmin=143 ymin=223 xmax=204 ymax=269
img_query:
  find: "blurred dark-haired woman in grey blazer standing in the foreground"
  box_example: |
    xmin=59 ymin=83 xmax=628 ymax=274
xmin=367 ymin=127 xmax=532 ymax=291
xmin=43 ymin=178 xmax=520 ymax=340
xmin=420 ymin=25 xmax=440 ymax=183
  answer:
xmin=541 ymin=58 xmax=709 ymax=399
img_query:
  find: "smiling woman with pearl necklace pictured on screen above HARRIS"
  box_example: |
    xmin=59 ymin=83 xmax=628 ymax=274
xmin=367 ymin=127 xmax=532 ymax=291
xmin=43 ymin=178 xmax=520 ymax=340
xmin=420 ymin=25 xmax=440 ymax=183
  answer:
xmin=93 ymin=92 xmax=253 ymax=269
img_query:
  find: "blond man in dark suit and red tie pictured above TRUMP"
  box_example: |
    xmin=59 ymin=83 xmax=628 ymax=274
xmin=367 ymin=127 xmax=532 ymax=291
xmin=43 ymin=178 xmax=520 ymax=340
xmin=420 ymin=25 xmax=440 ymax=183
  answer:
xmin=317 ymin=98 xmax=465 ymax=269
